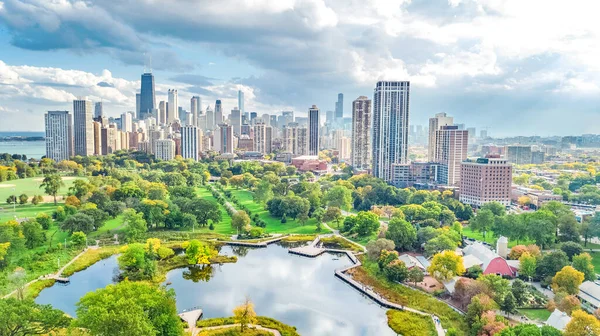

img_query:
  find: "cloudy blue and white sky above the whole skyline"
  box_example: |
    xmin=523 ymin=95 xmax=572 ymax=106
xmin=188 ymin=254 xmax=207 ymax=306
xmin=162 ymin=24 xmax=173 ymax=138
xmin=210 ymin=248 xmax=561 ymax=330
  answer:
xmin=0 ymin=0 xmax=600 ymax=136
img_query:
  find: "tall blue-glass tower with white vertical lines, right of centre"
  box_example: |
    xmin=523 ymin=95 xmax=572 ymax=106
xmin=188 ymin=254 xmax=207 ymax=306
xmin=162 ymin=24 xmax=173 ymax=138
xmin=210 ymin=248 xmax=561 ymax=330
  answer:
xmin=372 ymin=81 xmax=410 ymax=182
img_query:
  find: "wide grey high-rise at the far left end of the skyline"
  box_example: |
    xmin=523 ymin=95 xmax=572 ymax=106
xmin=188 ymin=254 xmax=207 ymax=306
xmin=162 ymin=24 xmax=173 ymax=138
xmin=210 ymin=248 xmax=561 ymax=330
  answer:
xmin=45 ymin=111 xmax=73 ymax=162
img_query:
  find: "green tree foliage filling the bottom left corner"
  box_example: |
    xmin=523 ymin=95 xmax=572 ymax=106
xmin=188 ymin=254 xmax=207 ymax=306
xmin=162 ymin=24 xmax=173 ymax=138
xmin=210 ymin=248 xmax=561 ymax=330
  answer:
xmin=0 ymin=298 xmax=71 ymax=336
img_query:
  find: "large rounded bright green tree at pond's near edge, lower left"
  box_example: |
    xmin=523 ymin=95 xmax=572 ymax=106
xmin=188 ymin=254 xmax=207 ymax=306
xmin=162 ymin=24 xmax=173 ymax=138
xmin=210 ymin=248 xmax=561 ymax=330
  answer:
xmin=77 ymin=281 xmax=183 ymax=336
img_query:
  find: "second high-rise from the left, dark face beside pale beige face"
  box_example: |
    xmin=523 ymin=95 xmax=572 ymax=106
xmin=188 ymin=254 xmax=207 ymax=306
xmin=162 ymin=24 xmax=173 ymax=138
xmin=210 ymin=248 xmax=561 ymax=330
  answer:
xmin=73 ymin=99 xmax=94 ymax=156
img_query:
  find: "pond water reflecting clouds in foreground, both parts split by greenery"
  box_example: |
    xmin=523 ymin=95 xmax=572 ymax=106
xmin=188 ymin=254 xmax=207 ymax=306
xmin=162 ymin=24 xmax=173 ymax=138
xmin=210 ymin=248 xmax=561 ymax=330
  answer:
xmin=36 ymin=245 xmax=396 ymax=336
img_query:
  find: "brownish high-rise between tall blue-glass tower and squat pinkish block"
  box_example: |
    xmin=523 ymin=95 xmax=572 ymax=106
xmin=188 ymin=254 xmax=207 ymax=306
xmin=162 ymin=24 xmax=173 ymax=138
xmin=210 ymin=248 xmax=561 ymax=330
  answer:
xmin=432 ymin=126 xmax=469 ymax=186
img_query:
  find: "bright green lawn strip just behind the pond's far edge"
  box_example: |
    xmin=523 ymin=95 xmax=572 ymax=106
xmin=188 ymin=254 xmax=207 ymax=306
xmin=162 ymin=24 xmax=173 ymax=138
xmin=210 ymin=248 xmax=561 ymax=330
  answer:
xmin=227 ymin=187 xmax=328 ymax=234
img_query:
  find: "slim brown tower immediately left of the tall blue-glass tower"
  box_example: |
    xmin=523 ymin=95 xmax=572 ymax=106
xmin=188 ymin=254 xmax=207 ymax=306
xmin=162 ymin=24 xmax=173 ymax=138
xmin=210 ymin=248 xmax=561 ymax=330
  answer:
xmin=351 ymin=96 xmax=372 ymax=170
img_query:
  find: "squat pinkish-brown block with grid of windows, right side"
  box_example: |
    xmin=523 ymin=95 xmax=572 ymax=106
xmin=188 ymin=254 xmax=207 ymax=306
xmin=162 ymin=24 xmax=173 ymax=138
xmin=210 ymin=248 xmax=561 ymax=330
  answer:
xmin=459 ymin=158 xmax=512 ymax=207
